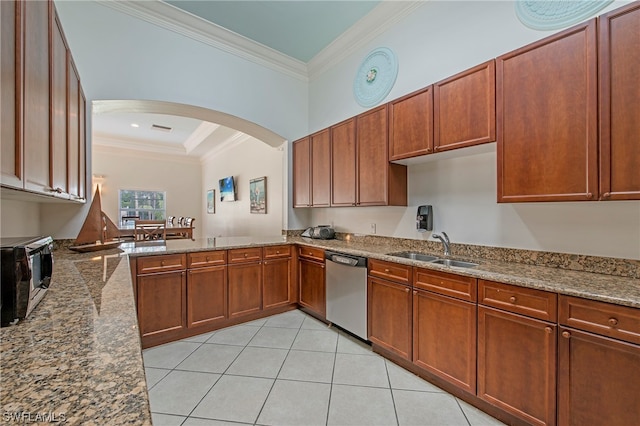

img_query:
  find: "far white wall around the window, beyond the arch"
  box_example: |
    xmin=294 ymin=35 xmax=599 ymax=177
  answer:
xmin=91 ymin=146 xmax=204 ymax=237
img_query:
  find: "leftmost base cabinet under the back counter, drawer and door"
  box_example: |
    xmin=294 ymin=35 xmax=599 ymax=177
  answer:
xmin=136 ymin=254 xmax=187 ymax=344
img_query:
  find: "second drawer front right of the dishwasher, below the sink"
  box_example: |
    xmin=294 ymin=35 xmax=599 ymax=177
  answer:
xmin=413 ymin=268 xmax=477 ymax=302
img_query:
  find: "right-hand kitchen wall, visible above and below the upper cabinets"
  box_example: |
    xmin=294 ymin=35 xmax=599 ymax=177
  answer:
xmin=309 ymin=1 xmax=640 ymax=259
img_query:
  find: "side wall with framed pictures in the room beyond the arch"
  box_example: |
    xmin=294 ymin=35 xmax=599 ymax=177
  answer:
xmin=201 ymin=138 xmax=286 ymax=237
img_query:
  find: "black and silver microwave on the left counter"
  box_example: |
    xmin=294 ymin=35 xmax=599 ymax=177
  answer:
xmin=0 ymin=237 xmax=53 ymax=327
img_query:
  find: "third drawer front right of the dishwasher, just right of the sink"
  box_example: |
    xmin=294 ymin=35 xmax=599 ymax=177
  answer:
xmin=478 ymin=280 xmax=558 ymax=322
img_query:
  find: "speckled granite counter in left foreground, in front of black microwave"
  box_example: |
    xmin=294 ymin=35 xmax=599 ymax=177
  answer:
xmin=0 ymin=249 xmax=151 ymax=425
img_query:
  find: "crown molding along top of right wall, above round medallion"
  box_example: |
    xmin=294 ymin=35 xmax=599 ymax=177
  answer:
xmin=307 ymin=0 xmax=425 ymax=79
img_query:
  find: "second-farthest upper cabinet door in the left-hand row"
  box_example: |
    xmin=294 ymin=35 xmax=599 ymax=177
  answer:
xmin=67 ymin=55 xmax=81 ymax=199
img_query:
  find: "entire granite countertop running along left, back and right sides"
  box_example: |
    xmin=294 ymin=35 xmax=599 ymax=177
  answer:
xmin=0 ymin=236 xmax=640 ymax=425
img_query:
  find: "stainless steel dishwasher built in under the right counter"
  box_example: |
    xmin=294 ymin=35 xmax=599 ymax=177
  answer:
xmin=325 ymin=250 xmax=367 ymax=340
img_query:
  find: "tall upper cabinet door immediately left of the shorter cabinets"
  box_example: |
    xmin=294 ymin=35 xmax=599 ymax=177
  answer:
xmin=356 ymin=105 xmax=389 ymax=206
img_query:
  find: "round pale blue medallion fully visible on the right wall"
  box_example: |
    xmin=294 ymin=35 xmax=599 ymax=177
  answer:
xmin=353 ymin=47 xmax=398 ymax=107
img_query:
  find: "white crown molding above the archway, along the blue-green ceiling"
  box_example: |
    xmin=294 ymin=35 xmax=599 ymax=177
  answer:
xmin=97 ymin=0 xmax=308 ymax=81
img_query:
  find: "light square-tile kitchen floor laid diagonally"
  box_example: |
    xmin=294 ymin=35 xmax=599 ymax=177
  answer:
xmin=143 ymin=310 xmax=502 ymax=426
